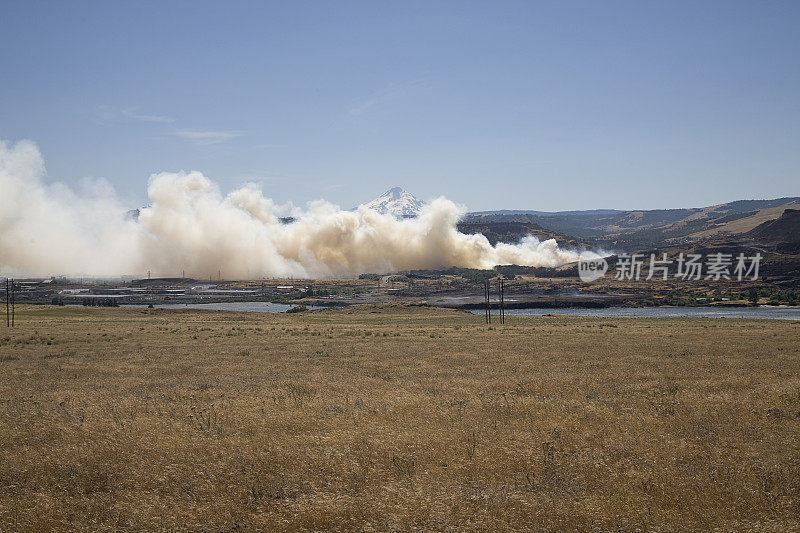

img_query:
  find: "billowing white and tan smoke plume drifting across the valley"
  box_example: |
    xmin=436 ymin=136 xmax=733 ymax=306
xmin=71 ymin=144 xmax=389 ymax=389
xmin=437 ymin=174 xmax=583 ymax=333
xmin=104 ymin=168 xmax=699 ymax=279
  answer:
xmin=0 ymin=141 xmax=595 ymax=278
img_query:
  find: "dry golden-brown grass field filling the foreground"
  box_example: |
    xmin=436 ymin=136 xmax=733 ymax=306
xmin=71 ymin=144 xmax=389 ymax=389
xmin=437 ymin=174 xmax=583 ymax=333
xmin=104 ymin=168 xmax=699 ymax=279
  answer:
xmin=0 ymin=307 xmax=800 ymax=531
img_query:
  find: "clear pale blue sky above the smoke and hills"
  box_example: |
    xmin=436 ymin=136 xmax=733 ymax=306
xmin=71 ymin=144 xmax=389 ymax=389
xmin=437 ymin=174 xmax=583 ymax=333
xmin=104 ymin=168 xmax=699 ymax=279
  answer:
xmin=0 ymin=0 xmax=800 ymax=210
